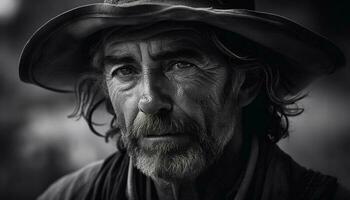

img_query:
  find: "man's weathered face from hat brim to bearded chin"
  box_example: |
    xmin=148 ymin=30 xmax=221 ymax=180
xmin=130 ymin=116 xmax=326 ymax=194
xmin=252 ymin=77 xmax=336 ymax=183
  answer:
xmin=103 ymin=31 xmax=239 ymax=180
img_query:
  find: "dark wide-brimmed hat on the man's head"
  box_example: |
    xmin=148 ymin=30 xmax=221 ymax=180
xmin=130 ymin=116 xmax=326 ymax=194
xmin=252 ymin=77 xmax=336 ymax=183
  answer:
xmin=19 ymin=0 xmax=345 ymax=95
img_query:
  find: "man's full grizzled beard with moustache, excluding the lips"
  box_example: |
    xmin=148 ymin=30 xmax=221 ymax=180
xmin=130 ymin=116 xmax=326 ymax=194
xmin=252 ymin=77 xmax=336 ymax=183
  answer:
xmin=121 ymin=99 xmax=235 ymax=182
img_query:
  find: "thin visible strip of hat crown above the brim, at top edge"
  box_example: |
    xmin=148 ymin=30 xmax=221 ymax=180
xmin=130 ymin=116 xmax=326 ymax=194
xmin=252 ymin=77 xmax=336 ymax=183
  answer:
xmin=104 ymin=0 xmax=255 ymax=10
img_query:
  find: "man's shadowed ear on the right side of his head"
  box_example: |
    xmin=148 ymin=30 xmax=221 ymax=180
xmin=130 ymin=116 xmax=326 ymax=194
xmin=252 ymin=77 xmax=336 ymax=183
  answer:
xmin=238 ymin=72 xmax=262 ymax=108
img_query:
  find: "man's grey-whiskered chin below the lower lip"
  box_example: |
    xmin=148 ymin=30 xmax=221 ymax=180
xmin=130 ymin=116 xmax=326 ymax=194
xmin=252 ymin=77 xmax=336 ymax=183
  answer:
xmin=131 ymin=145 xmax=208 ymax=182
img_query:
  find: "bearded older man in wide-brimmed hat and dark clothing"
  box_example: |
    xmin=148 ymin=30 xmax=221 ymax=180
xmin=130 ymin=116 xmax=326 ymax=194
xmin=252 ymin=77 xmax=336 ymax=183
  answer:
xmin=20 ymin=0 xmax=350 ymax=200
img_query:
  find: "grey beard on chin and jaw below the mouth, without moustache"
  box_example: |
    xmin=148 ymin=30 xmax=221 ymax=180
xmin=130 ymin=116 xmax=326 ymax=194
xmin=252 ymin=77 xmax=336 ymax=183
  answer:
xmin=122 ymin=129 xmax=227 ymax=182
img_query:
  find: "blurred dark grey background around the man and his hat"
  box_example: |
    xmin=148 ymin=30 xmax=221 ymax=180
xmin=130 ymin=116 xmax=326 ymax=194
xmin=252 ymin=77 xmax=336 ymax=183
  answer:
xmin=0 ymin=0 xmax=350 ymax=200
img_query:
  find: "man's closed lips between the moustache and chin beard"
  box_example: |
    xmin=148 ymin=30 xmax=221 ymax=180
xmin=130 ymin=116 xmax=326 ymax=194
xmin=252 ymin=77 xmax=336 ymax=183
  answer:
xmin=140 ymin=134 xmax=191 ymax=147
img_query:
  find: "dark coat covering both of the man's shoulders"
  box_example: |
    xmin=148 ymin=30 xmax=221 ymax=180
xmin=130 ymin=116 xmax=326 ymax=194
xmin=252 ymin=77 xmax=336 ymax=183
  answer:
xmin=39 ymin=143 xmax=350 ymax=200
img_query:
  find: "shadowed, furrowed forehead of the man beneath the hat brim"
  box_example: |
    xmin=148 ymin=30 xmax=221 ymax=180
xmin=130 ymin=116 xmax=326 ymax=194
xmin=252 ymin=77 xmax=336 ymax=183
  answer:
xmin=103 ymin=24 xmax=210 ymax=52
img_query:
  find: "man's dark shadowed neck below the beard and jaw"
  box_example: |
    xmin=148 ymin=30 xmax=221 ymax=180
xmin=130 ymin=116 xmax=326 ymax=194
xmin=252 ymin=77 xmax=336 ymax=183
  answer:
xmin=154 ymin=128 xmax=249 ymax=200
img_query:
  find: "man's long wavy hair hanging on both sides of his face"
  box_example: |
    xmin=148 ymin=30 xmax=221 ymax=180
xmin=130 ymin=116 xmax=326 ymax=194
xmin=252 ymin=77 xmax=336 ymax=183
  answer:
xmin=69 ymin=24 xmax=305 ymax=145
